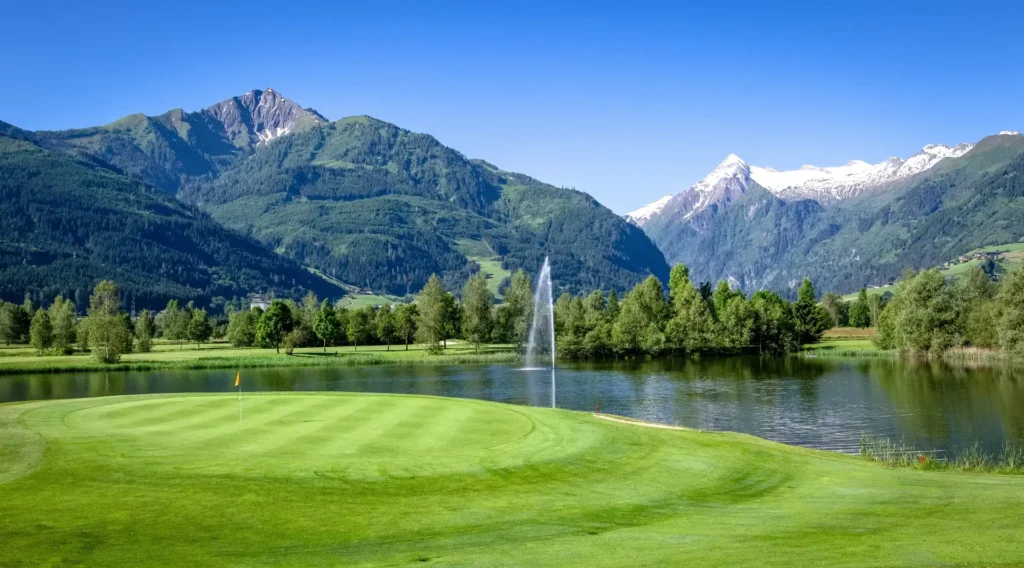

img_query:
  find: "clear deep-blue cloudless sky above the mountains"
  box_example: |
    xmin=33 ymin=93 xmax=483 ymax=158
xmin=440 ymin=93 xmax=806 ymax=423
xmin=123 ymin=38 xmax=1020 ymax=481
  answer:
xmin=0 ymin=0 xmax=1024 ymax=213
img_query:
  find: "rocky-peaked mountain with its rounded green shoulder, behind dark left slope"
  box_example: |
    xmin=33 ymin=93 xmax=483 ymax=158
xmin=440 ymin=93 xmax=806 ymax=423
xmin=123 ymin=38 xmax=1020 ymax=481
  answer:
xmin=6 ymin=88 xmax=668 ymax=295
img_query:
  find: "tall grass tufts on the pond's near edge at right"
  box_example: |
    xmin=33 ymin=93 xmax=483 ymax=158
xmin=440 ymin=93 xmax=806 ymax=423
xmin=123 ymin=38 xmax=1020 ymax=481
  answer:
xmin=860 ymin=435 xmax=1024 ymax=474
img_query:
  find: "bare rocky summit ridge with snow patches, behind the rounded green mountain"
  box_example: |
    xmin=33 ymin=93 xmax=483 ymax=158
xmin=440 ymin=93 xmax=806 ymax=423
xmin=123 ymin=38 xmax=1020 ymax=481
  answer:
xmin=35 ymin=88 xmax=328 ymax=193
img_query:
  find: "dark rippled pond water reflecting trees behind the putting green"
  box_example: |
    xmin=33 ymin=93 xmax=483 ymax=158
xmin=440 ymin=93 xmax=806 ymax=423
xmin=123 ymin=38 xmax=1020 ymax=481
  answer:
xmin=0 ymin=357 xmax=1024 ymax=453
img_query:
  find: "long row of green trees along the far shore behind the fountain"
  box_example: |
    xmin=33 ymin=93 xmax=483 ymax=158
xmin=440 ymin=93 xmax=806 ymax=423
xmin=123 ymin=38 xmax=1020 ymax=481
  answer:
xmin=0 ymin=265 xmax=834 ymax=361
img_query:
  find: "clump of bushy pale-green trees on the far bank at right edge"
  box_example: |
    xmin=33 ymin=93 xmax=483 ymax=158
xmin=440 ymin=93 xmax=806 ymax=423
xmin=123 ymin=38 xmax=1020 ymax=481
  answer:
xmin=876 ymin=267 xmax=1024 ymax=355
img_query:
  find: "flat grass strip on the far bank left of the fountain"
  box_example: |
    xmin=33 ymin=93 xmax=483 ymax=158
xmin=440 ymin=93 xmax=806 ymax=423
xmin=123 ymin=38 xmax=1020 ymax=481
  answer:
xmin=0 ymin=341 xmax=519 ymax=375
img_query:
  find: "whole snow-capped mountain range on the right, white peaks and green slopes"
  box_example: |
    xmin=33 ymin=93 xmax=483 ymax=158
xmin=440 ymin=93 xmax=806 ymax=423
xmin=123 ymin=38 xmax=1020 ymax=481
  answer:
xmin=625 ymin=131 xmax=1024 ymax=296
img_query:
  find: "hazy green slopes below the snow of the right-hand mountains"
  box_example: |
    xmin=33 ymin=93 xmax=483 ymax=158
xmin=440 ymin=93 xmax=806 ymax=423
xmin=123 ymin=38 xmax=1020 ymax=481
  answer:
xmin=644 ymin=135 xmax=1024 ymax=294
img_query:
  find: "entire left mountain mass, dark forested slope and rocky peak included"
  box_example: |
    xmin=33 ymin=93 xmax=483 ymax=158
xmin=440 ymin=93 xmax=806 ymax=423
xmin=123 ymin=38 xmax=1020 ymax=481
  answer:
xmin=0 ymin=89 xmax=669 ymax=307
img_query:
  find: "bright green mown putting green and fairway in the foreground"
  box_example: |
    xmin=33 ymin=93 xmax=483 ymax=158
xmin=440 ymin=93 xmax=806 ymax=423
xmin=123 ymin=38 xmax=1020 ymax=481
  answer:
xmin=0 ymin=393 xmax=1024 ymax=567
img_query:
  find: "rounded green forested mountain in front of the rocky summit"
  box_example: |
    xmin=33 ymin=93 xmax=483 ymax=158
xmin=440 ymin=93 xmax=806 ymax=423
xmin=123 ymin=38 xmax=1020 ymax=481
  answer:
xmin=179 ymin=117 xmax=668 ymax=294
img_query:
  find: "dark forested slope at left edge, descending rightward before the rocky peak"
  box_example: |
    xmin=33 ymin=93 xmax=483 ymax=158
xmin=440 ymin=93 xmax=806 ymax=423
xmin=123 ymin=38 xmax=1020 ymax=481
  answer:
xmin=0 ymin=122 xmax=344 ymax=309
